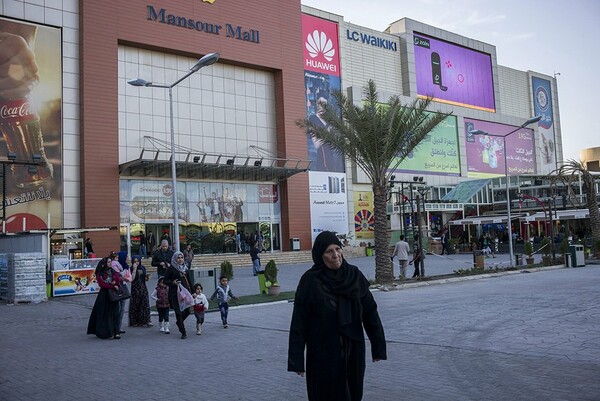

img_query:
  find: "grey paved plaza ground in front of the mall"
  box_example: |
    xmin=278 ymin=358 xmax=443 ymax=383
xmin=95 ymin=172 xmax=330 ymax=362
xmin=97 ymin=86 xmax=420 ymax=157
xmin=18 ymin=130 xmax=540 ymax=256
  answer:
xmin=0 ymin=255 xmax=600 ymax=401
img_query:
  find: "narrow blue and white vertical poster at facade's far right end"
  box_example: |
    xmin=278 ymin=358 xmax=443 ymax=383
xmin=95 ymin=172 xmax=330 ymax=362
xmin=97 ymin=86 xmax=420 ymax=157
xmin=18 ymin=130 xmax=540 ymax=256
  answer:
xmin=531 ymin=77 xmax=556 ymax=174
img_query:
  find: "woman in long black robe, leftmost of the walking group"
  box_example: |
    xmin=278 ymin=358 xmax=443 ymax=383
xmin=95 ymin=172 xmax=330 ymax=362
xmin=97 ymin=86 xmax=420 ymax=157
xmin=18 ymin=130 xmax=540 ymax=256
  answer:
xmin=87 ymin=258 xmax=121 ymax=339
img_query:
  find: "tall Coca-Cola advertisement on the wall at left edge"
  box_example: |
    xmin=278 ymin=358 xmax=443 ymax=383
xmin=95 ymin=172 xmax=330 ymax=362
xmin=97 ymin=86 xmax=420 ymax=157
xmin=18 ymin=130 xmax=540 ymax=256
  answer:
xmin=0 ymin=18 xmax=63 ymax=232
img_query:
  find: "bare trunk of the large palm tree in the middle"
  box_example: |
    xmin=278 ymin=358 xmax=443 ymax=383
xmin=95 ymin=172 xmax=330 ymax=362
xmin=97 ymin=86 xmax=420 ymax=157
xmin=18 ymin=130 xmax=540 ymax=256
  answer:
xmin=373 ymin=182 xmax=394 ymax=284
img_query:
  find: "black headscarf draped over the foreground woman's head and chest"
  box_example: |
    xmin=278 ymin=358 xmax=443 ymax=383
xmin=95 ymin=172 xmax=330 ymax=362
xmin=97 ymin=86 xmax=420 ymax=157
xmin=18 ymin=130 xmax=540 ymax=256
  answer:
xmin=312 ymin=231 xmax=369 ymax=340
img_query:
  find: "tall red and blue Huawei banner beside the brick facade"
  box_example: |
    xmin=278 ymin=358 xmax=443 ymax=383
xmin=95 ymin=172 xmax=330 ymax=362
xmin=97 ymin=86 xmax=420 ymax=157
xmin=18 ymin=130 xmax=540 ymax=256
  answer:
xmin=302 ymin=15 xmax=345 ymax=173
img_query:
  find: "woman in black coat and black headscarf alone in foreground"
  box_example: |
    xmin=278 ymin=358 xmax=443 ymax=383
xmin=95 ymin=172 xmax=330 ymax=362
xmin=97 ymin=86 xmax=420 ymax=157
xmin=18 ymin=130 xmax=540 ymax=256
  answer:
xmin=288 ymin=231 xmax=387 ymax=401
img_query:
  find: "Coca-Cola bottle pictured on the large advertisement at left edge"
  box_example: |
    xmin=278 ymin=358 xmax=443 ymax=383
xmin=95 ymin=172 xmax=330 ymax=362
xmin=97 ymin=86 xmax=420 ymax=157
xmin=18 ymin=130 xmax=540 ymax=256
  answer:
xmin=0 ymin=98 xmax=53 ymax=187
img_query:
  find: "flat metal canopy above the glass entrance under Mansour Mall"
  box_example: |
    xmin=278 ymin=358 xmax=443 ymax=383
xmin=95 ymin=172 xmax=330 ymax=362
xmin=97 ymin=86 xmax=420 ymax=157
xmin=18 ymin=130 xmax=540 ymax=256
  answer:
xmin=119 ymin=139 xmax=310 ymax=182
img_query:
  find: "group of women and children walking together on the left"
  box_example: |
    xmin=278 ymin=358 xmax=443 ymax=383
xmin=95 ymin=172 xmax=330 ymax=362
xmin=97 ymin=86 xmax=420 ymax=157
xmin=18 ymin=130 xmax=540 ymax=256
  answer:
xmin=87 ymin=247 xmax=237 ymax=339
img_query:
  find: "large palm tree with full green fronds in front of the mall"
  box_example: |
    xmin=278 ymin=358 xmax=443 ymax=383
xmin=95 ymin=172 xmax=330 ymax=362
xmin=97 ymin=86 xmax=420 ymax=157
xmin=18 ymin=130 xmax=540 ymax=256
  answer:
xmin=296 ymin=80 xmax=449 ymax=284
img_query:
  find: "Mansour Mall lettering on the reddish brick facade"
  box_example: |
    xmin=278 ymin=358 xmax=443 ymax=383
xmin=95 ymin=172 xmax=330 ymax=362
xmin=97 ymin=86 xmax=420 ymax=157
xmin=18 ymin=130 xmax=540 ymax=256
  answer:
xmin=146 ymin=5 xmax=260 ymax=44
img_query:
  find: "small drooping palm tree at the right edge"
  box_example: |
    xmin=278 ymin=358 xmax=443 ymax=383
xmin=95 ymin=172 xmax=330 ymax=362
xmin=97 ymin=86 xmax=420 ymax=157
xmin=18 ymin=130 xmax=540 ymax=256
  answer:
xmin=550 ymin=159 xmax=600 ymax=247
